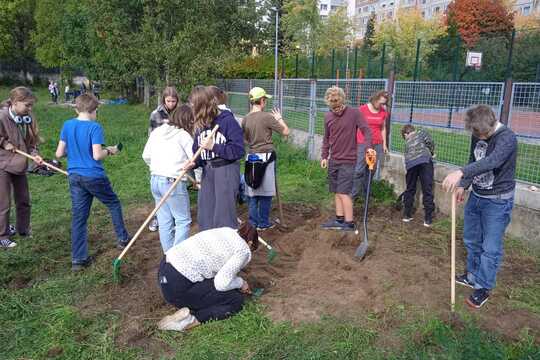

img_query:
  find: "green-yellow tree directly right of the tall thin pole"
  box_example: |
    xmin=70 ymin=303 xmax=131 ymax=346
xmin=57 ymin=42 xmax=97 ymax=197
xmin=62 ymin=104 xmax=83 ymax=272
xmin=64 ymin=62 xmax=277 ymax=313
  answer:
xmin=282 ymin=0 xmax=322 ymax=53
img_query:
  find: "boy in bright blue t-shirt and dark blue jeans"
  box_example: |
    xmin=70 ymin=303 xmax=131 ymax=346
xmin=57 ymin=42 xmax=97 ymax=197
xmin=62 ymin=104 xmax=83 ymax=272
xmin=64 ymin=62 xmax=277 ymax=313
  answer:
xmin=56 ymin=94 xmax=129 ymax=271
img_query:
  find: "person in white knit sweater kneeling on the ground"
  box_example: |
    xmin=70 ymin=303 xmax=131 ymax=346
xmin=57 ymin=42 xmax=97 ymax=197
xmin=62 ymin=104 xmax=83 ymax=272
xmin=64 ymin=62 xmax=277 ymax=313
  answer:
xmin=158 ymin=222 xmax=259 ymax=331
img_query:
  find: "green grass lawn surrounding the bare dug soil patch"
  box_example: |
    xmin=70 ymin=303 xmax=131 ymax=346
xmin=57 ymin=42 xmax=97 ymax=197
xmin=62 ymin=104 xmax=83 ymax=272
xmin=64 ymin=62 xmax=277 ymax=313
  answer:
xmin=0 ymin=88 xmax=540 ymax=359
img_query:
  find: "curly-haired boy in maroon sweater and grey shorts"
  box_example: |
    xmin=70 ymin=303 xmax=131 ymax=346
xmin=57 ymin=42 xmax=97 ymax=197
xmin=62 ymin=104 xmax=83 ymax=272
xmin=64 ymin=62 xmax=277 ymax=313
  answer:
xmin=321 ymin=86 xmax=371 ymax=231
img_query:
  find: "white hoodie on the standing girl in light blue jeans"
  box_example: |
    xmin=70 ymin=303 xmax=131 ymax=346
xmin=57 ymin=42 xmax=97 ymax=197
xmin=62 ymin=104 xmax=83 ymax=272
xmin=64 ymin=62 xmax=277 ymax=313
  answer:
xmin=142 ymin=123 xmax=200 ymax=181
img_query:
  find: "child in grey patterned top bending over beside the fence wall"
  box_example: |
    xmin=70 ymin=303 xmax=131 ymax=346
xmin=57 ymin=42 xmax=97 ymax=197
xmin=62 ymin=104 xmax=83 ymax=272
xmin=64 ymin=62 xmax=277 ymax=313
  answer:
xmin=401 ymin=125 xmax=435 ymax=227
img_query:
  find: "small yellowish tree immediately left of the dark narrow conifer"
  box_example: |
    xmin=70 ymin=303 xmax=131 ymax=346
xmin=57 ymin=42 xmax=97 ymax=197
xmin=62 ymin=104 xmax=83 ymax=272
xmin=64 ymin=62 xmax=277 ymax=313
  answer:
xmin=318 ymin=7 xmax=352 ymax=54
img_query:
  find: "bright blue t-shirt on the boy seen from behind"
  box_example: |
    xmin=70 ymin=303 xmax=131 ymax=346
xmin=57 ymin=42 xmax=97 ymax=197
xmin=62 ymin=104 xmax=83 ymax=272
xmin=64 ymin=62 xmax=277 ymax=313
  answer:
xmin=60 ymin=119 xmax=106 ymax=178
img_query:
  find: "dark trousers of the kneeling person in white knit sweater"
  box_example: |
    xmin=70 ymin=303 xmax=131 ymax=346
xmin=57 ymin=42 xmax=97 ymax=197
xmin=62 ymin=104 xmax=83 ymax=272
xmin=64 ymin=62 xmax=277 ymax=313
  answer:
xmin=158 ymin=258 xmax=244 ymax=323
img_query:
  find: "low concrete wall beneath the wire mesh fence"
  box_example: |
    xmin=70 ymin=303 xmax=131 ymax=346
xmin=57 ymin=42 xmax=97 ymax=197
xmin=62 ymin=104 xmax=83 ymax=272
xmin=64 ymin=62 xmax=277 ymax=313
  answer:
xmin=290 ymin=130 xmax=540 ymax=248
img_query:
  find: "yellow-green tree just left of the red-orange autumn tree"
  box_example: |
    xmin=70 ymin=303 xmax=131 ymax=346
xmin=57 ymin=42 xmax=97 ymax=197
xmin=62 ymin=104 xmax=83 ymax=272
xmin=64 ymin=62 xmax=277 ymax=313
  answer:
xmin=374 ymin=10 xmax=446 ymax=76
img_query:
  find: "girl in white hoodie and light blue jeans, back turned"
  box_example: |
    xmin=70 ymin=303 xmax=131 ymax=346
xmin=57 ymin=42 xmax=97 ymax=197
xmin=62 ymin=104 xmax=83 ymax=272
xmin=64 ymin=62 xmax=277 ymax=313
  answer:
xmin=143 ymin=105 xmax=199 ymax=252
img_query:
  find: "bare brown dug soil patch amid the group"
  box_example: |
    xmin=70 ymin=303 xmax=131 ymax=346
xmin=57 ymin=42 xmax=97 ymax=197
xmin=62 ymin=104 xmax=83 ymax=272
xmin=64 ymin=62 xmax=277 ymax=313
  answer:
xmin=82 ymin=204 xmax=540 ymax=351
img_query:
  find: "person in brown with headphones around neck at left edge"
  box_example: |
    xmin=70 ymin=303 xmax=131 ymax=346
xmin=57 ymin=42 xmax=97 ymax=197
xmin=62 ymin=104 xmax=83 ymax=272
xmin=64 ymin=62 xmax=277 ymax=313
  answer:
xmin=0 ymin=86 xmax=42 ymax=249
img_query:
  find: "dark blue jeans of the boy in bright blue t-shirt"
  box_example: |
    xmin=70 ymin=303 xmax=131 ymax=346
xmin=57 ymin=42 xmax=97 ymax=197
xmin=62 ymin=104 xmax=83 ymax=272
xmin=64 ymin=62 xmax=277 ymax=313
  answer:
xmin=69 ymin=174 xmax=129 ymax=264
